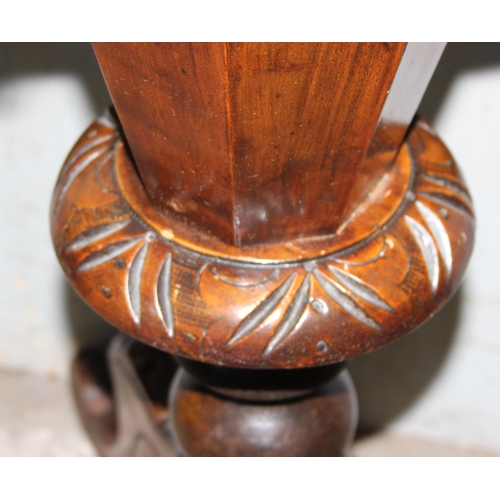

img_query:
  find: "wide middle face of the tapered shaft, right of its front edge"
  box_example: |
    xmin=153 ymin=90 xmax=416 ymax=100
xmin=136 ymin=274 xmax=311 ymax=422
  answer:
xmin=227 ymin=43 xmax=406 ymax=245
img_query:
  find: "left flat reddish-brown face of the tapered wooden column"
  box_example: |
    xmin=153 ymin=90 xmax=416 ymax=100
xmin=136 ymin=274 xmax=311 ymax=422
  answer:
xmin=94 ymin=43 xmax=235 ymax=242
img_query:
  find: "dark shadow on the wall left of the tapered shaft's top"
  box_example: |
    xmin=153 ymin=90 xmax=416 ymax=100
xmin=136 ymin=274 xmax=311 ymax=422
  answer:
xmin=0 ymin=43 xmax=111 ymax=116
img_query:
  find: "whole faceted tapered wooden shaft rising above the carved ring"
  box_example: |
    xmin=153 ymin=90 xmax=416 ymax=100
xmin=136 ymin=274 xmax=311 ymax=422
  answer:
xmin=94 ymin=43 xmax=439 ymax=246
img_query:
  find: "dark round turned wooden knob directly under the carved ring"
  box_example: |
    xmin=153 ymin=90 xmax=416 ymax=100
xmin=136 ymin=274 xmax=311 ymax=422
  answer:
xmin=169 ymin=370 xmax=357 ymax=457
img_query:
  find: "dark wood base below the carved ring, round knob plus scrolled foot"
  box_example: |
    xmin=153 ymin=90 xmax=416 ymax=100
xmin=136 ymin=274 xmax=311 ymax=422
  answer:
xmin=73 ymin=334 xmax=357 ymax=456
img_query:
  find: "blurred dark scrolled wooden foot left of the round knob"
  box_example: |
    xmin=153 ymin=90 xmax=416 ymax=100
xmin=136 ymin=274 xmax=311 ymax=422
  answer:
xmin=72 ymin=334 xmax=177 ymax=457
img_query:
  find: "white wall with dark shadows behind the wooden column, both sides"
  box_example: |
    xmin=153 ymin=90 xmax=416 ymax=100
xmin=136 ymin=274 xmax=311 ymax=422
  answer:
xmin=0 ymin=43 xmax=500 ymax=453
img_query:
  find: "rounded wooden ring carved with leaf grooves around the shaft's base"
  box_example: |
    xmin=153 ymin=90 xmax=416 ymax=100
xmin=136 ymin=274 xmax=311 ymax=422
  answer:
xmin=52 ymin=114 xmax=474 ymax=368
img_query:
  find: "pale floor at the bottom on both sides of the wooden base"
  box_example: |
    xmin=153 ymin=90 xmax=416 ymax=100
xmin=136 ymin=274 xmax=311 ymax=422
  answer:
xmin=0 ymin=372 xmax=496 ymax=457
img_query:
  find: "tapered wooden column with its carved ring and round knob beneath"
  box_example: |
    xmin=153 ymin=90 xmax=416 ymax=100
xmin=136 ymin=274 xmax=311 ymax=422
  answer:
xmin=52 ymin=43 xmax=473 ymax=455
